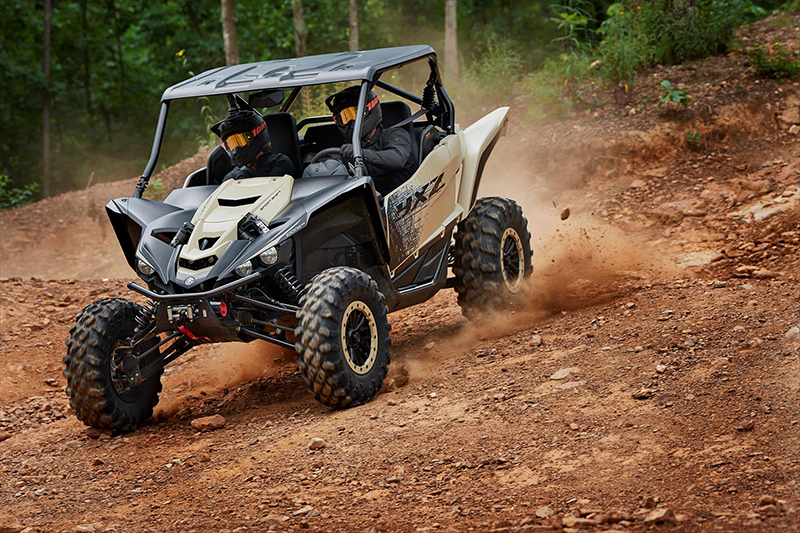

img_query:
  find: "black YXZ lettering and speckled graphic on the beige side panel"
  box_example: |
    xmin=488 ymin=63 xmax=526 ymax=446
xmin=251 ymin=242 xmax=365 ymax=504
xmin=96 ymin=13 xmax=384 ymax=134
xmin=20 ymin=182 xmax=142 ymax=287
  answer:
xmin=386 ymin=172 xmax=445 ymax=260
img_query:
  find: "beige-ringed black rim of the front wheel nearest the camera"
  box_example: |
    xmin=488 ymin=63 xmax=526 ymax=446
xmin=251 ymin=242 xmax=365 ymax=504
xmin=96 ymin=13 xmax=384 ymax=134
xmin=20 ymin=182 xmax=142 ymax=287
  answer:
xmin=341 ymin=300 xmax=378 ymax=375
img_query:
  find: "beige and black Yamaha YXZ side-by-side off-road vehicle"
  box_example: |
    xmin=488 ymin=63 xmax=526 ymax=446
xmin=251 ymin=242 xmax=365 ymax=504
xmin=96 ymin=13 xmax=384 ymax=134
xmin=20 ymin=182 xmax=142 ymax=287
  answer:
xmin=64 ymin=46 xmax=532 ymax=430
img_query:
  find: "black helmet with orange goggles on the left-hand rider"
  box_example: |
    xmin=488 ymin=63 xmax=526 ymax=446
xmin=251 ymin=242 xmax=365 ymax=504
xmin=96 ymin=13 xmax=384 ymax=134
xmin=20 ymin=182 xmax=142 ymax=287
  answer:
xmin=211 ymin=107 xmax=270 ymax=167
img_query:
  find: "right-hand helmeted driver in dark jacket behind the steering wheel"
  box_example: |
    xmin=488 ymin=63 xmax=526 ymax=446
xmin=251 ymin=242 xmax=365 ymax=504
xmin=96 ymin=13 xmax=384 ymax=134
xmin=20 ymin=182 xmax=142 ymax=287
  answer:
xmin=325 ymin=86 xmax=414 ymax=195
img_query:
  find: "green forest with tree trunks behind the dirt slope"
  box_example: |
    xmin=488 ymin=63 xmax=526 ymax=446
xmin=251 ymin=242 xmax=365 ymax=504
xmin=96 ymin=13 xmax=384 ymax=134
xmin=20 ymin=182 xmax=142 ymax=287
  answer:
xmin=0 ymin=0 xmax=800 ymax=207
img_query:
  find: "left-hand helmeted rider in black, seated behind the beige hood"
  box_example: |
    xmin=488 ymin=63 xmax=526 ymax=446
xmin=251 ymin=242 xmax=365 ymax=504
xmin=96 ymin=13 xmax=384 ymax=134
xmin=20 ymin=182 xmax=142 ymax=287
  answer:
xmin=211 ymin=107 xmax=294 ymax=182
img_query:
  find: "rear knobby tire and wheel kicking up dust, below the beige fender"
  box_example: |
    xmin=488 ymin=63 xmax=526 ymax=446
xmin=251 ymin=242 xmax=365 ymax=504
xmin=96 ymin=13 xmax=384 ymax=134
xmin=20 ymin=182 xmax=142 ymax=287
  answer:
xmin=453 ymin=198 xmax=533 ymax=318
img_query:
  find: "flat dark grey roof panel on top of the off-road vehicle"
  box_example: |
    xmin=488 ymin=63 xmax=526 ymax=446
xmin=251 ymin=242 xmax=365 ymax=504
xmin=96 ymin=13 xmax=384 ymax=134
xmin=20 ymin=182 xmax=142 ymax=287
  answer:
xmin=161 ymin=45 xmax=436 ymax=101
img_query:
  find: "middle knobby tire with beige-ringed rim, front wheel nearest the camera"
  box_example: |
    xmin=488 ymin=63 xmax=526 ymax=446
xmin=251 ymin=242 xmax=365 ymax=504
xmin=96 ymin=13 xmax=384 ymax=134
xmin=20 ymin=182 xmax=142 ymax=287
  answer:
xmin=295 ymin=267 xmax=392 ymax=409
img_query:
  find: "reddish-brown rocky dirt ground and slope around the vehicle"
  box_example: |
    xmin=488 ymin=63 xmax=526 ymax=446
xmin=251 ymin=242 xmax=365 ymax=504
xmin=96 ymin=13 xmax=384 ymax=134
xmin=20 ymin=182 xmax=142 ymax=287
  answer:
xmin=0 ymin=11 xmax=800 ymax=532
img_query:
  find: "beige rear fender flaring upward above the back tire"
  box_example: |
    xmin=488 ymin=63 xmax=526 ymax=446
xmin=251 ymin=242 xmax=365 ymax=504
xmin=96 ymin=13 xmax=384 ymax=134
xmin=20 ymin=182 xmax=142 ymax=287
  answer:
xmin=458 ymin=107 xmax=509 ymax=213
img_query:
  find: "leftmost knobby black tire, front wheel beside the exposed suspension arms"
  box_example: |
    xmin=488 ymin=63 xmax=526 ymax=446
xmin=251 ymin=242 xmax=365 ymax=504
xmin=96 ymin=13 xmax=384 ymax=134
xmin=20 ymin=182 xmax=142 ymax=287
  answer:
xmin=64 ymin=298 xmax=161 ymax=431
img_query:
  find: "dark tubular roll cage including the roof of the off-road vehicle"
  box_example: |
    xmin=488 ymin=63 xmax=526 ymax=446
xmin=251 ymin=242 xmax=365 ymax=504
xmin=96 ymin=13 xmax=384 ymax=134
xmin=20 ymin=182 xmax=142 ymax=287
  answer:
xmin=133 ymin=45 xmax=455 ymax=198
